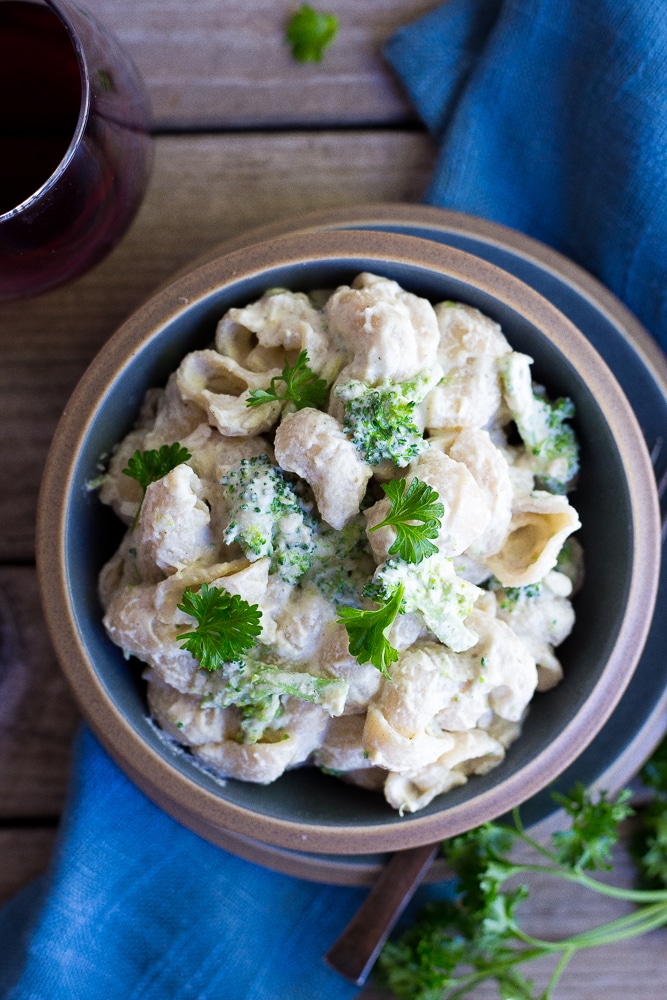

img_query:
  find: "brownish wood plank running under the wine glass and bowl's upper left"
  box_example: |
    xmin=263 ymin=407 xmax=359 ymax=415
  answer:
xmin=0 ymin=130 xmax=434 ymax=562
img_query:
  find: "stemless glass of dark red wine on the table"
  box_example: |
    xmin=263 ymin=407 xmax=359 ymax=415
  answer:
xmin=0 ymin=0 xmax=152 ymax=299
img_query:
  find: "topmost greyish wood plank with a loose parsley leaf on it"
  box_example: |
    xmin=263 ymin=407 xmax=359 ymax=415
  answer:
xmin=82 ymin=0 xmax=440 ymax=130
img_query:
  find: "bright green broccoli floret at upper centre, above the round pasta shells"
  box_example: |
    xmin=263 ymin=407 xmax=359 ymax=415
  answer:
xmin=335 ymin=372 xmax=442 ymax=468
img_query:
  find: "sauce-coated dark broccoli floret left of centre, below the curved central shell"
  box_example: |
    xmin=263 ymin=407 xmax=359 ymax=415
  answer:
xmin=220 ymin=455 xmax=317 ymax=583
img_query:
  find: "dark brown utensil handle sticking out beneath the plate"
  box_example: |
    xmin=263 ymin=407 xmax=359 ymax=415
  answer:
xmin=324 ymin=843 xmax=440 ymax=986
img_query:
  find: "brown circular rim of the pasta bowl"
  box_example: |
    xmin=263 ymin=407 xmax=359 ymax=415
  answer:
xmin=36 ymin=229 xmax=660 ymax=854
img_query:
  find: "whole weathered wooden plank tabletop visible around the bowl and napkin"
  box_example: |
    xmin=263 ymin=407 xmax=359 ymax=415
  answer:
xmin=0 ymin=0 xmax=667 ymax=1000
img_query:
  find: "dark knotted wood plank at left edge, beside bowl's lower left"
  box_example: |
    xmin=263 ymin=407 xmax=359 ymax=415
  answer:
xmin=0 ymin=566 xmax=79 ymax=820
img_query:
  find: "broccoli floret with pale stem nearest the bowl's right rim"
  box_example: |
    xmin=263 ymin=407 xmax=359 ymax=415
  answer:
xmin=500 ymin=352 xmax=579 ymax=493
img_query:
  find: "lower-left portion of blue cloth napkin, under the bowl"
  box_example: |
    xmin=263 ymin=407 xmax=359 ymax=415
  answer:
xmin=0 ymin=729 xmax=365 ymax=1000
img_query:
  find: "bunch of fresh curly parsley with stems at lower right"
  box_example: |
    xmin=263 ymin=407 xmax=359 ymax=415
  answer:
xmin=376 ymin=756 xmax=667 ymax=1000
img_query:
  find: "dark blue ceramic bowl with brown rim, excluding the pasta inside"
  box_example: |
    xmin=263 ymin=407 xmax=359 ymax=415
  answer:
xmin=37 ymin=230 xmax=660 ymax=864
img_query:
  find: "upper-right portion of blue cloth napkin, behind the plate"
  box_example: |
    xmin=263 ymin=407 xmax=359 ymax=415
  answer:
xmin=385 ymin=0 xmax=667 ymax=349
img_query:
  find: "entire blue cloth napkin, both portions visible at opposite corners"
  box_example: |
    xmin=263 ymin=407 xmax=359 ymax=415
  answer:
xmin=0 ymin=0 xmax=667 ymax=1000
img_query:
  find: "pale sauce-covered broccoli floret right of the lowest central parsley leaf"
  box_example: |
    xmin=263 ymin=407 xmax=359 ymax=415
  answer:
xmin=364 ymin=552 xmax=482 ymax=653
